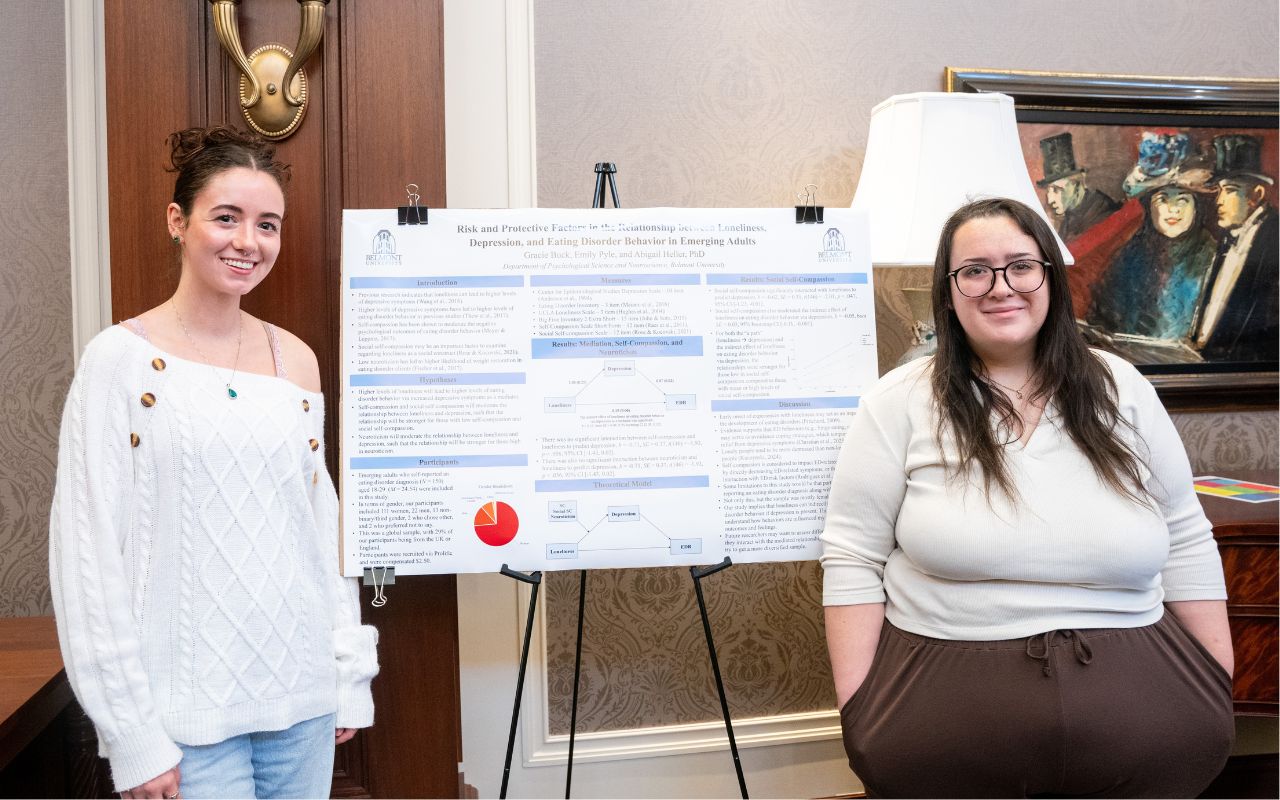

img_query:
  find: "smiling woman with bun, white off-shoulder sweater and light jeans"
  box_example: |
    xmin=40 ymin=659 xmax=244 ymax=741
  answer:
xmin=49 ymin=128 xmax=378 ymax=800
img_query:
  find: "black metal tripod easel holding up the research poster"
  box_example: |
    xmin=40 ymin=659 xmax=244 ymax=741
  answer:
xmin=498 ymin=161 xmax=747 ymax=800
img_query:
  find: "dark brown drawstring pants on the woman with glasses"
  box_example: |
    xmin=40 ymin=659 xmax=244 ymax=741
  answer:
xmin=840 ymin=613 xmax=1235 ymax=797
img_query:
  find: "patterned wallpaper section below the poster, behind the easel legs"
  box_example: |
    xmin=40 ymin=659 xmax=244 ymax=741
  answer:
xmin=543 ymin=561 xmax=833 ymax=733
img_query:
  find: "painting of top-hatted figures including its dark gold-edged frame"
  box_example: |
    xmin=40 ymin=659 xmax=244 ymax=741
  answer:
xmin=946 ymin=67 xmax=1280 ymax=406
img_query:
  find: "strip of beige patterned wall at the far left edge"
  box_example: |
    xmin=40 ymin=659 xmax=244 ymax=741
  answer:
xmin=0 ymin=3 xmax=73 ymax=617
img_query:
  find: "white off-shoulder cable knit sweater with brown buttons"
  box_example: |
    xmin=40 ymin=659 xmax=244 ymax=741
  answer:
xmin=49 ymin=325 xmax=378 ymax=790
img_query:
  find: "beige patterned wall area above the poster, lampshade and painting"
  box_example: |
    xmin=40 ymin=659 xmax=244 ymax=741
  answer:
xmin=534 ymin=0 xmax=1277 ymax=207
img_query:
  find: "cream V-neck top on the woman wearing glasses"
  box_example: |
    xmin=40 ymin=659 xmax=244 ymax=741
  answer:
xmin=822 ymin=351 xmax=1226 ymax=640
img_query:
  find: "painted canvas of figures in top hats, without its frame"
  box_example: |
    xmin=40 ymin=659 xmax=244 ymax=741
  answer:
xmin=1019 ymin=123 xmax=1280 ymax=364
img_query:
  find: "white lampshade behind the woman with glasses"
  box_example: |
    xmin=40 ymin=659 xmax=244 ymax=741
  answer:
xmin=854 ymin=92 xmax=1074 ymax=266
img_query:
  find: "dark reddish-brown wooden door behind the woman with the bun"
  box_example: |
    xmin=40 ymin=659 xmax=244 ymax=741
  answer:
xmin=104 ymin=0 xmax=462 ymax=797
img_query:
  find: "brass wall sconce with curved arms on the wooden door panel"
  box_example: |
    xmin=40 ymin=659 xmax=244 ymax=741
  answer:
xmin=209 ymin=0 xmax=329 ymax=140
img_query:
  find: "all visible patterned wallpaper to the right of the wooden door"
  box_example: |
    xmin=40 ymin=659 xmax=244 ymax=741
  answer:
xmin=534 ymin=0 xmax=1280 ymax=732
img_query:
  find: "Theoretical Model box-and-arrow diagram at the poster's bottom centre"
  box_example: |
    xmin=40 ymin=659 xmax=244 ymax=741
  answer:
xmin=547 ymin=500 xmax=703 ymax=559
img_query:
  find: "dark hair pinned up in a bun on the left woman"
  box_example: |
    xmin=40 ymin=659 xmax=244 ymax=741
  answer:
xmin=169 ymin=125 xmax=289 ymax=216
